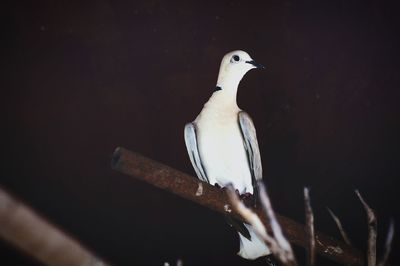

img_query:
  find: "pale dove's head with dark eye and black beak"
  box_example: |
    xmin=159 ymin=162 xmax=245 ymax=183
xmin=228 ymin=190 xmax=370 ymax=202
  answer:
xmin=217 ymin=50 xmax=265 ymax=89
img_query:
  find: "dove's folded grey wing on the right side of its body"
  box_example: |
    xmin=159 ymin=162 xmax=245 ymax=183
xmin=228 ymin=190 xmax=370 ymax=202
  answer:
xmin=238 ymin=111 xmax=262 ymax=198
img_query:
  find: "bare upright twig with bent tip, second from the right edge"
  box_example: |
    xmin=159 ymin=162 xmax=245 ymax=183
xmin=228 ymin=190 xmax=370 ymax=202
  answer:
xmin=355 ymin=190 xmax=377 ymax=266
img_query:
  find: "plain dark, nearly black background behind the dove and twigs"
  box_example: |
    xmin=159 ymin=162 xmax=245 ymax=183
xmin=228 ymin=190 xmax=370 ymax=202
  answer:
xmin=0 ymin=0 xmax=400 ymax=265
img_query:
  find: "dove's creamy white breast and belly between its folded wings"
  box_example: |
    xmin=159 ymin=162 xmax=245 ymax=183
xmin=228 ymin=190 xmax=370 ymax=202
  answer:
xmin=196 ymin=108 xmax=253 ymax=194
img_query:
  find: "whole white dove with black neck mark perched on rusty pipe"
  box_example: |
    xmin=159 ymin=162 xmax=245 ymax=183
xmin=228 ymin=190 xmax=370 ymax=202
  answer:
xmin=184 ymin=50 xmax=271 ymax=260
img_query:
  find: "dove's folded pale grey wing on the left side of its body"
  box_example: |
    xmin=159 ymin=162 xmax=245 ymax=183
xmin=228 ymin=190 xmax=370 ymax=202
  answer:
xmin=185 ymin=123 xmax=209 ymax=182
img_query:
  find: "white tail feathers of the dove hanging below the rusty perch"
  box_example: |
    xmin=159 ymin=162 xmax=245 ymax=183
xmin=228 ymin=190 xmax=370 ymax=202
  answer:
xmin=237 ymin=224 xmax=271 ymax=260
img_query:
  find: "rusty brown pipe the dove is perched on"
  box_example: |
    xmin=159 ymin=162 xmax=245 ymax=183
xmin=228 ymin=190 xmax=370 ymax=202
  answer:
xmin=111 ymin=147 xmax=364 ymax=266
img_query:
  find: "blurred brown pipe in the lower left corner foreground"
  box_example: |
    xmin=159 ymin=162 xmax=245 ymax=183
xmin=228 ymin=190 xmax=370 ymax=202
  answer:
xmin=0 ymin=188 xmax=108 ymax=266
